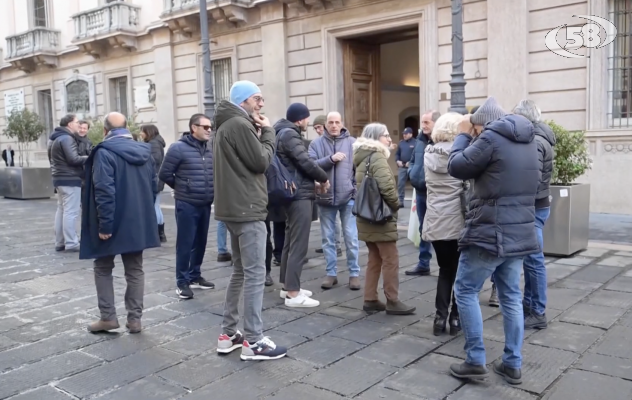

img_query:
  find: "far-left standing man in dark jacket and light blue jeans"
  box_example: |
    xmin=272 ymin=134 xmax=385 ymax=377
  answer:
xmin=48 ymin=114 xmax=88 ymax=252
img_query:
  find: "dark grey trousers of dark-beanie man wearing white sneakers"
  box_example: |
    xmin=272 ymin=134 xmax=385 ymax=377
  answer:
xmin=279 ymin=200 xmax=313 ymax=291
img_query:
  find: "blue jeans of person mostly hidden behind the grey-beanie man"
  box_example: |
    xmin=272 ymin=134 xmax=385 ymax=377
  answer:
xmin=522 ymin=207 xmax=551 ymax=315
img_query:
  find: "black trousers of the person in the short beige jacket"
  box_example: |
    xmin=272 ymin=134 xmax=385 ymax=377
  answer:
xmin=432 ymin=240 xmax=461 ymax=318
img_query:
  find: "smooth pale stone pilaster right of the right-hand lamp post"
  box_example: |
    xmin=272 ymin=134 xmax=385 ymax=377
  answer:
xmin=487 ymin=0 xmax=528 ymax=112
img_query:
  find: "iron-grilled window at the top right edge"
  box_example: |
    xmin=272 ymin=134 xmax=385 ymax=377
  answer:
xmin=607 ymin=0 xmax=632 ymax=128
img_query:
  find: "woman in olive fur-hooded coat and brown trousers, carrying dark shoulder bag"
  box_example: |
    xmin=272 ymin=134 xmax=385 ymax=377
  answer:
xmin=353 ymin=123 xmax=415 ymax=315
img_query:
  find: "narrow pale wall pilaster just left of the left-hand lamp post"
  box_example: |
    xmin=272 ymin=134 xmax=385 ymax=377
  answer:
xmin=153 ymin=28 xmax=180 ymax=144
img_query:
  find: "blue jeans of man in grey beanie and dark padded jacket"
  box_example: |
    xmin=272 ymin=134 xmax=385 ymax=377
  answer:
xmin=454 ymin=246 xmax=524 ymax=368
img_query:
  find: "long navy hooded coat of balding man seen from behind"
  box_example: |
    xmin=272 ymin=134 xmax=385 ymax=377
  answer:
xmin=79 ymin=129 xmax=160 ymax=260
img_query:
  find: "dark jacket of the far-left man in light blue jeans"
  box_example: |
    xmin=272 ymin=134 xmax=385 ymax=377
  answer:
xmin=48 ymin=126 xmax=88 ymax=187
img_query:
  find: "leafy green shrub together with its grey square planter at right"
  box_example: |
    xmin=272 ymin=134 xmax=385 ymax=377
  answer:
xmin=543 ymin=121 xmax=592 ymax=256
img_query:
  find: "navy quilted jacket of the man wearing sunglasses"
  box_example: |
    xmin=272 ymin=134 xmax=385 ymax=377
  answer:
xmin=158 ymin=132 xmax=214 ymax=207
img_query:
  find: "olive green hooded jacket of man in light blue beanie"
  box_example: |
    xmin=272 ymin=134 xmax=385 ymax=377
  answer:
xmin=213 ymin=100 xmax=275 ymax=222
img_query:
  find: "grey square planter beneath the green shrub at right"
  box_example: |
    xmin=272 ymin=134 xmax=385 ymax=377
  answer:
xmin=543 ymin=183 xmax=590 ymax=257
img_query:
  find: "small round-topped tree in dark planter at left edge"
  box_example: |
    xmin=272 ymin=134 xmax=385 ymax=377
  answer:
xmin=0 ymin=108 xmax=53 ymax=200
